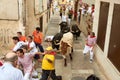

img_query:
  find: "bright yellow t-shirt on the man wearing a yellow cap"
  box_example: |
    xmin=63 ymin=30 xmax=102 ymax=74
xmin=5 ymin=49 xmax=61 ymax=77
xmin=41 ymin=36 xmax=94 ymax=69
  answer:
xmin=42 ymin=54 xmax=55 ymax=70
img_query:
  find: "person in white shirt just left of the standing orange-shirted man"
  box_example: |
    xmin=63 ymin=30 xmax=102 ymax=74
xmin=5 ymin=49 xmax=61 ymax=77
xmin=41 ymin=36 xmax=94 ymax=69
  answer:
xmin=27 ymin=36 xmax=38 ymax=54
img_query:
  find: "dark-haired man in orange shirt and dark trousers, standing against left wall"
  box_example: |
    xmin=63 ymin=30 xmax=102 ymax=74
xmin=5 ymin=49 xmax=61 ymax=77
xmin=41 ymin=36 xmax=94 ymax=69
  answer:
xmin=33 ymin=27 xmax=44 ymax=52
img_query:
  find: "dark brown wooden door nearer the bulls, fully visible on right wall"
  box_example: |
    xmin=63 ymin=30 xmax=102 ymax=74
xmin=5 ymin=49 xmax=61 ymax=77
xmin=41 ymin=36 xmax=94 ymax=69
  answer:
xmin=97 ymin=2 xmax=109 ymax=51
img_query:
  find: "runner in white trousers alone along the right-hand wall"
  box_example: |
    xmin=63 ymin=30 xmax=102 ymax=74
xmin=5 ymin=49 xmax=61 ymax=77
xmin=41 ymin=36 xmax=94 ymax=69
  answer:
xmin=83 ymin=32 xmax=97 ymax=63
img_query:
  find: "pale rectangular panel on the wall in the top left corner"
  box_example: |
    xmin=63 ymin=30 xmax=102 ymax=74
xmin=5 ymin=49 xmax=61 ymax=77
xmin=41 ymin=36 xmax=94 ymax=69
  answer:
xmin=0 ymin=0 xmax=19 ymax=20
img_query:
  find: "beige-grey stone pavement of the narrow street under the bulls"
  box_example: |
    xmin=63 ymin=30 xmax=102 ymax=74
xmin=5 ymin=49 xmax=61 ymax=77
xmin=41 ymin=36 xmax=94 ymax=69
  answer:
xmin=43 ymin=14 xmax=107 ymax=80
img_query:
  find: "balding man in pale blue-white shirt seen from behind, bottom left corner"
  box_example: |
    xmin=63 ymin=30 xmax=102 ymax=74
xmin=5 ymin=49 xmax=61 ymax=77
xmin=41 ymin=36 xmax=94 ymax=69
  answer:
xmin=0 ymin=52 xmax=24 ymax=80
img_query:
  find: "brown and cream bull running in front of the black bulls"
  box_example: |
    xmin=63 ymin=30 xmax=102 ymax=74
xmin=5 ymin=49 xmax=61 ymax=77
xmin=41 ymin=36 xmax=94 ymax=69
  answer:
xmin=60 ymin=32 xmax=73 ymax=66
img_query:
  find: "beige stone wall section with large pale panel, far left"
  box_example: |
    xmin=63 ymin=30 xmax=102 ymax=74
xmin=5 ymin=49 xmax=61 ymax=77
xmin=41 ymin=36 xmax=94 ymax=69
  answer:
xmin=0 ymin=0 xmax=24 ymax=47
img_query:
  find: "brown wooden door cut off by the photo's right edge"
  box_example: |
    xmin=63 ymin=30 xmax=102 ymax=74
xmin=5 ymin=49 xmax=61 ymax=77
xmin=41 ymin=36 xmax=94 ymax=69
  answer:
xmin=108 ymin=4 xmax=120 ymax=71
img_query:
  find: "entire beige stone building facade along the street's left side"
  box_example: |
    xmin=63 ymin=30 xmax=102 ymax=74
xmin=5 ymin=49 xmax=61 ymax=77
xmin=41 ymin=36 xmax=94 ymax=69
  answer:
xmin=0 ymin=0 xmax=51 ymax=46
